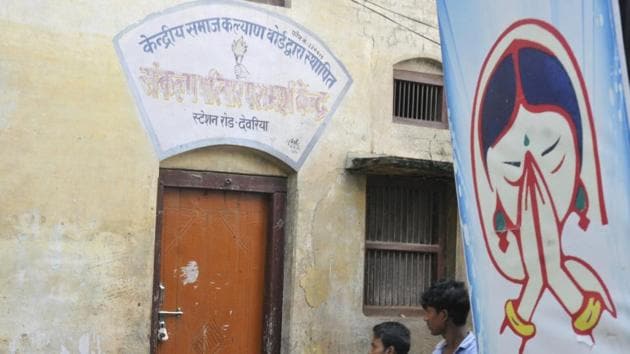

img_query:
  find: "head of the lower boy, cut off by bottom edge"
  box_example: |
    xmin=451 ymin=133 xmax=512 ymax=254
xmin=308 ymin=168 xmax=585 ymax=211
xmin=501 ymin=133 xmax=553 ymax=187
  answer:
xmin=370 ymin=322 xmax=411 ymax=354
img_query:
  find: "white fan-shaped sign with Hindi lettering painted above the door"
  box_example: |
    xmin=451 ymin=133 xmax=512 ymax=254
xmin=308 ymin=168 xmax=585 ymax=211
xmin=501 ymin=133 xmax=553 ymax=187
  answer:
xmin=114 ymin=1 xmax=352 ymax=170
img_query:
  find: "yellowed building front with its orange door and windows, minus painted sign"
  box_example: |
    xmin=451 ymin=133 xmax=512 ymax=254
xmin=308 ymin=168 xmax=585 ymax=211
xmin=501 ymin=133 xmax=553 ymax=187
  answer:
xmin=0 ymin=0 xmax=465 ymax=353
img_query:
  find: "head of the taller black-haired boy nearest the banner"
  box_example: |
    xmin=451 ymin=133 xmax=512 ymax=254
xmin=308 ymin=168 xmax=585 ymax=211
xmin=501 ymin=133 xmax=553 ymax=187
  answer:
xmin=421 ymin=280 xmax=470 ymax=335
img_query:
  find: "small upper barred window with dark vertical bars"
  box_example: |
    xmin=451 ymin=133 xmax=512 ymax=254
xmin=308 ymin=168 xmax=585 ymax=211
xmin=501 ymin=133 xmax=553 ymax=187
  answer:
xmin=393 ymin=70 xmax=448 ymax=128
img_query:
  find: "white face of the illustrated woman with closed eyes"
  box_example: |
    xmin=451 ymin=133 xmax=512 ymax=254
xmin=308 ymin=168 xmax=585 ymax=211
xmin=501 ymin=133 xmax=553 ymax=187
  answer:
xmin=487 ymin=105 xmax=578 ymax=221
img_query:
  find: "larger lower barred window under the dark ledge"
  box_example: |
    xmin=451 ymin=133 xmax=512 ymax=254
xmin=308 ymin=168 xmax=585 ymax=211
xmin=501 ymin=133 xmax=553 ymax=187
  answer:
xmin=363 ymin=176 xmax=450 ymax=316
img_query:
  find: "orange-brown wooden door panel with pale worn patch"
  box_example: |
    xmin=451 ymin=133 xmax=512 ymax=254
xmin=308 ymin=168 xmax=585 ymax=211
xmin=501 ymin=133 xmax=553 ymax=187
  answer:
xmin=157 ymin=187 xmax=270 ymax=354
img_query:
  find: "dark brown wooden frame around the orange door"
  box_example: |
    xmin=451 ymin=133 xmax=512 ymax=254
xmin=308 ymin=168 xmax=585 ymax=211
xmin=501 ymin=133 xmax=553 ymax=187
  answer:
xmin=150 ymin=168 xmax=287 ymax=354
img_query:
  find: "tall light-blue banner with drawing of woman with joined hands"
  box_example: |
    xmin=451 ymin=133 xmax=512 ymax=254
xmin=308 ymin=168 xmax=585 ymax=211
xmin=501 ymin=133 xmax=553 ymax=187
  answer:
xmin=438 ymin=0 xmax=630 ymax=354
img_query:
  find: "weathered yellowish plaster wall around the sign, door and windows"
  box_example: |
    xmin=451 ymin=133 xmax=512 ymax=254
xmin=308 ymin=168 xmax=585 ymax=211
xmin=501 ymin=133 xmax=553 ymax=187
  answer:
xmin=0 ymin=0 xmax=462 ymax=353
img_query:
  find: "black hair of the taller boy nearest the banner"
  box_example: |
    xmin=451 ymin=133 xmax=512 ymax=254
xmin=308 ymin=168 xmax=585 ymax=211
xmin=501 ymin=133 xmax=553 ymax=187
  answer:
xmin=421 ymin=280 xmax=470 ymax=326
